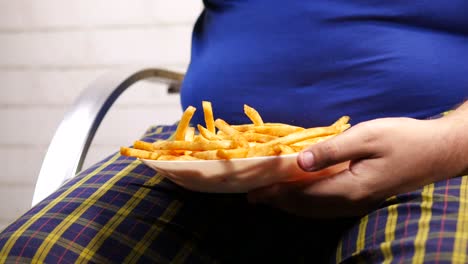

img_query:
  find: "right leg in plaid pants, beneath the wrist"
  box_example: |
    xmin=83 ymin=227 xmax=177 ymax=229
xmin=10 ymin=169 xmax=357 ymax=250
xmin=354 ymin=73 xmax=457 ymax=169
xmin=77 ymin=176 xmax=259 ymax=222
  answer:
xmin=336 ymin=176 xmax=468 ymax=263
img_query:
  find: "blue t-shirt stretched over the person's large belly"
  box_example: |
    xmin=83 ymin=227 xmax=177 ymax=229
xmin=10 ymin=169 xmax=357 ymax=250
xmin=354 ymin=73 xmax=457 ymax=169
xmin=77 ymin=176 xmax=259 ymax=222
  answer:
xmin=181 ymin=0 xmax=468 ymax=126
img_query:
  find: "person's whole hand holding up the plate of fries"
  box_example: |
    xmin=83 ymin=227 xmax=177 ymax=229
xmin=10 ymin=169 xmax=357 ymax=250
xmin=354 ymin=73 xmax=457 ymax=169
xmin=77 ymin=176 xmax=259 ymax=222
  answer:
xmin=248 ymin=118 xmax=468 ymax=217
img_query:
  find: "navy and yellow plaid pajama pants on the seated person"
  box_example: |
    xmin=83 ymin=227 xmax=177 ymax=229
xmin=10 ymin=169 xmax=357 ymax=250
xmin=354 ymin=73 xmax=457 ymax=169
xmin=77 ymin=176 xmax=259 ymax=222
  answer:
xmin=0 ymin=126 xmax=468 ymax=263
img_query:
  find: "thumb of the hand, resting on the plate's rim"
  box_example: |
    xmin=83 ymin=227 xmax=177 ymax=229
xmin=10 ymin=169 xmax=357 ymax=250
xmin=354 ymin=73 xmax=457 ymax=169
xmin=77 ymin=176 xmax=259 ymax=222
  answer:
xmin=297 ymin=125 xmax=376 ymax=171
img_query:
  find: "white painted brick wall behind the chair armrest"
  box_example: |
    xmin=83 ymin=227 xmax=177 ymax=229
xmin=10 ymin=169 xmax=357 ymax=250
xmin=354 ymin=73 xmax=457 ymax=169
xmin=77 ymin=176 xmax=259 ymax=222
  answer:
xmin=0 ymin=0 xmax=201 ymax=229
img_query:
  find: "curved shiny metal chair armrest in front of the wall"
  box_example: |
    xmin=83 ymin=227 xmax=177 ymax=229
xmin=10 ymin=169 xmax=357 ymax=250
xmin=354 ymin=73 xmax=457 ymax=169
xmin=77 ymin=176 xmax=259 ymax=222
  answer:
xmin=32 ymin=68 xmax=184 ymax=206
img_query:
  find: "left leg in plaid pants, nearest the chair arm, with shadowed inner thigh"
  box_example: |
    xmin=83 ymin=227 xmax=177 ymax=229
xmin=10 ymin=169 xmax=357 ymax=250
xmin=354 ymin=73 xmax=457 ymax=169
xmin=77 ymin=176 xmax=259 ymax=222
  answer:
xmin=0 ymin=127 xmax=352 ymax=263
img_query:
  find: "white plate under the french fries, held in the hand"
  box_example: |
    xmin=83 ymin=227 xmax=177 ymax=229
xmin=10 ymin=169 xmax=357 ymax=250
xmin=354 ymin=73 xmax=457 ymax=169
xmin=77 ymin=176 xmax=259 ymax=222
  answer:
xmin=141 ymin=154 xmax=348 ymax=193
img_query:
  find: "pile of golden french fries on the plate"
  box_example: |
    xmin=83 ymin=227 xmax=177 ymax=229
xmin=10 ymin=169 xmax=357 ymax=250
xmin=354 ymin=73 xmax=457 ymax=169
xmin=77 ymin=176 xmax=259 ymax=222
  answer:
xmin=120 ymin=101 xmax=351 ymax=161
